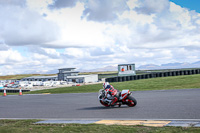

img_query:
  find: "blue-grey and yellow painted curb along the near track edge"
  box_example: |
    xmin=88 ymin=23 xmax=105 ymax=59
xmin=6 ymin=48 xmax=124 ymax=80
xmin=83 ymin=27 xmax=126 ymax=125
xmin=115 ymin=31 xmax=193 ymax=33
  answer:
xmin=36 ymin=120 xmax=200 ymax=127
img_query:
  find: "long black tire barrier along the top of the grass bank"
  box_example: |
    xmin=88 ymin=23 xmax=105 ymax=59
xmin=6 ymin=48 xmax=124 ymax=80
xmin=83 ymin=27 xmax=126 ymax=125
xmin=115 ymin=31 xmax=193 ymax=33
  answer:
xmin=106 ymin=69 xmax=200 ymax=82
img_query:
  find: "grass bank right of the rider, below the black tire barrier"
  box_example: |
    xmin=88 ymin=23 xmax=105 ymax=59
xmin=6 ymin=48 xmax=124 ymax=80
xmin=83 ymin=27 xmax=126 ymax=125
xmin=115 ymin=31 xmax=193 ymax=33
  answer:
xmin=113 ymin=74 xmax=200 ymax=90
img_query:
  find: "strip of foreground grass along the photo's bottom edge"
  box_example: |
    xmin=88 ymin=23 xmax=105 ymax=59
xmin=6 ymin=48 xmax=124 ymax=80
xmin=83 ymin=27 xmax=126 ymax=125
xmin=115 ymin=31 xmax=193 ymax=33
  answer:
xmin=0 ymin=120 xmax=200 ymax=133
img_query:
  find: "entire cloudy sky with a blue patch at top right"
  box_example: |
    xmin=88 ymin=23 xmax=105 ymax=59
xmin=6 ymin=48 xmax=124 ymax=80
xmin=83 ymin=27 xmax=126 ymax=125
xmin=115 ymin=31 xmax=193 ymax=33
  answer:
xmin=0 ymin=0 xmax=200 ymax=75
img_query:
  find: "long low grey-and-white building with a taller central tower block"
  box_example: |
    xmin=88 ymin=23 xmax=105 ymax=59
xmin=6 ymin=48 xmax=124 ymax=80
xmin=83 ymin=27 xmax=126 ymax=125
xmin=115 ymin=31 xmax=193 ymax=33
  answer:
xmin=22 ymin=68 xmax=98 ymax=83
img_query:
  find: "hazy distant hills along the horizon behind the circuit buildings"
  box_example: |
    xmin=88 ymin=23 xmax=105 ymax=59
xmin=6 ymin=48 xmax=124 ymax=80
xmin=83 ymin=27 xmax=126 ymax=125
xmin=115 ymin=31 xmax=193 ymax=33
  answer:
xmin=0 ymin=61 xmax=200 ymax=80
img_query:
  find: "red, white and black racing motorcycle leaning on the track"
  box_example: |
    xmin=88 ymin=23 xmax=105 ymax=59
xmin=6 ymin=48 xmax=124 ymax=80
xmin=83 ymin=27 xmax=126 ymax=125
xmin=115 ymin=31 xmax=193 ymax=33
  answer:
xmin=98 ymin=89 xmax=137 ymax=107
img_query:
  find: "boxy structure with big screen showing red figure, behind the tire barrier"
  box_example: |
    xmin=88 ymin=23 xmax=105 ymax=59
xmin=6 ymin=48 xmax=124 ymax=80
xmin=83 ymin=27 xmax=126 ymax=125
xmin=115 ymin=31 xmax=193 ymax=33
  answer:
xmin=118 ymin=64 xmax=136 ymax=76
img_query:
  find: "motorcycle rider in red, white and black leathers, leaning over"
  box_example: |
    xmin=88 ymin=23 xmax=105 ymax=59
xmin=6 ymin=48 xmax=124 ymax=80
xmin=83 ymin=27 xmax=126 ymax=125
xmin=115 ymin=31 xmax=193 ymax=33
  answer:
xmin=103 ymin=82 xmax=119 ymax=106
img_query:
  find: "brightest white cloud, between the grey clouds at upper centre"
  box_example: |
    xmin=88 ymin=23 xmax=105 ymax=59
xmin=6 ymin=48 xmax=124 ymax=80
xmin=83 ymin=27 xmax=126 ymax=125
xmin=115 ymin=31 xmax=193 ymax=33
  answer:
xmin=43 ymin=2 xmax=116 ymax=48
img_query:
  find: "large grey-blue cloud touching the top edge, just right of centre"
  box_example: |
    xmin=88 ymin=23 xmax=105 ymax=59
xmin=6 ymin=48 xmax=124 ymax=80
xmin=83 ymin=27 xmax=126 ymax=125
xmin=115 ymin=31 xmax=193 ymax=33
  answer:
xmin=83 ymin=0 xmax=129 ymax=22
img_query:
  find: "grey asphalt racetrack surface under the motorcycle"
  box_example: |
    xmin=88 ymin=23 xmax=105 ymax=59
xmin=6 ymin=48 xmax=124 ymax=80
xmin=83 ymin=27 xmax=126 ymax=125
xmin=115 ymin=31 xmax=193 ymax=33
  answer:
xmin=0 ymin=89 xmax=200 ymax=120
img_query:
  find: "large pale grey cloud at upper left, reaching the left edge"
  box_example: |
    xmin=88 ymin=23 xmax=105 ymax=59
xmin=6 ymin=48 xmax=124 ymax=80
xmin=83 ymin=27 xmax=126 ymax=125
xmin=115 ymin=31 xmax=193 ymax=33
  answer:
xmin=0 ymin=0 xmax=59 ymax=46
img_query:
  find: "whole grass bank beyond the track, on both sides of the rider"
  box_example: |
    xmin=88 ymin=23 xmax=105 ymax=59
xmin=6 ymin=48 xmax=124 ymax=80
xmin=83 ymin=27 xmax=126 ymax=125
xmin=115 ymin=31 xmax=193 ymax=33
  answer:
xmin=24 ymin=74 xmax=200 ymax=94
